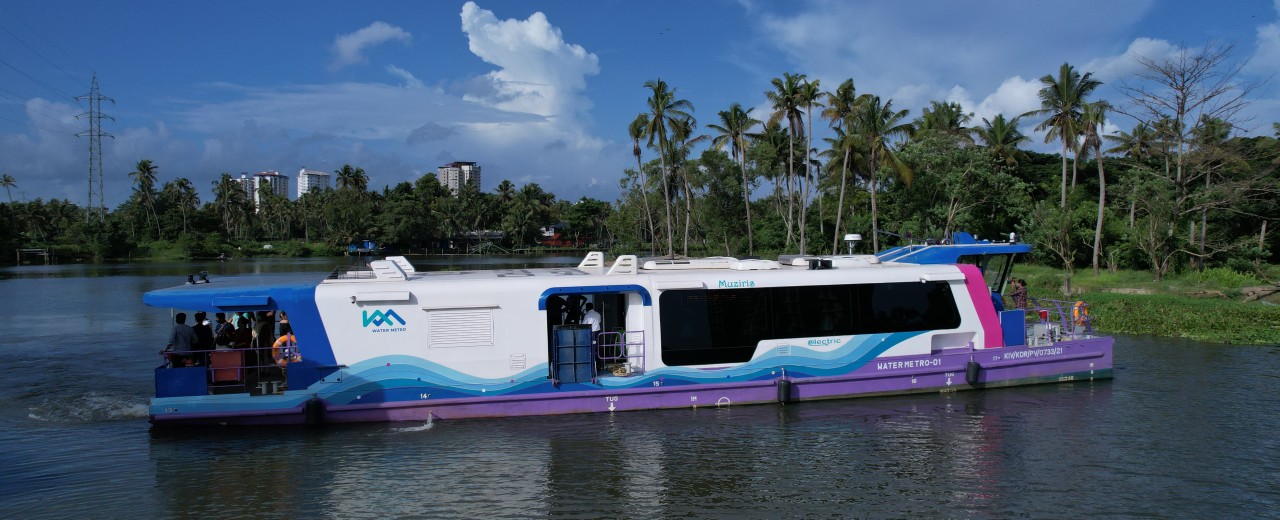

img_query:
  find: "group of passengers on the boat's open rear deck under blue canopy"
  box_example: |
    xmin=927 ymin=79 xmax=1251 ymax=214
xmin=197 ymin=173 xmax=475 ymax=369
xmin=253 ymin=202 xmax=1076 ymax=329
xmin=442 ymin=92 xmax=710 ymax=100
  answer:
xmin=165 ymin=310 xmax=297 ymax=366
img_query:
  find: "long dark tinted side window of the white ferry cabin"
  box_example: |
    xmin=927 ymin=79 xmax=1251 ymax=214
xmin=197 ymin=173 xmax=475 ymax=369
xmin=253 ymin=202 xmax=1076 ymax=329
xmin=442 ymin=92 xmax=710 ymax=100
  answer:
xmin=659 ymin=282 xmax=960 ymax=366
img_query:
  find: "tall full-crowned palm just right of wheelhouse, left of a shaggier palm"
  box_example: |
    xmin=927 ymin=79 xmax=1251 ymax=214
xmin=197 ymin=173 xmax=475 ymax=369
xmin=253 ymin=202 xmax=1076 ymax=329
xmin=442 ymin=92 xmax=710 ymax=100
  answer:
xmin=1023 ymin=63 xmax=1102 ymax=207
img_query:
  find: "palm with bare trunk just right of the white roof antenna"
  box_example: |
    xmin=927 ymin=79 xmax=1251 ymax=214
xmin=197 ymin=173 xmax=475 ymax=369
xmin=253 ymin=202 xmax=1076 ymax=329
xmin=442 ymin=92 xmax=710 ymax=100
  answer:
xmin=851 ymin=93 xmax=913 ymax=251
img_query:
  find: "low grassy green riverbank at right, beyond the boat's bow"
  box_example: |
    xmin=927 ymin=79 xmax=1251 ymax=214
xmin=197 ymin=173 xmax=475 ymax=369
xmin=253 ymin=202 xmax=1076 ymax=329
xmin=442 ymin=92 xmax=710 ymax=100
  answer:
xmin=1014 ymin=265 xmax=1280 ymax=345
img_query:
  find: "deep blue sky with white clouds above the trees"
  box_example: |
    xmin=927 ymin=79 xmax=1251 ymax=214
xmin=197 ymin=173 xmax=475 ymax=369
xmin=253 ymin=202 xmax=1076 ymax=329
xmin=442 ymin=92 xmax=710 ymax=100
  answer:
xmin=0 ymin=0 xmax=1280 ymax=207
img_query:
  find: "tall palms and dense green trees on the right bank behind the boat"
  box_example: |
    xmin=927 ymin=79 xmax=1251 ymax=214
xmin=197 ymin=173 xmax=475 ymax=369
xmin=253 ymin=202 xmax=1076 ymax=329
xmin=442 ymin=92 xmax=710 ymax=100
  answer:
xmin=609 ymin=45 xmax=1280 ymax=278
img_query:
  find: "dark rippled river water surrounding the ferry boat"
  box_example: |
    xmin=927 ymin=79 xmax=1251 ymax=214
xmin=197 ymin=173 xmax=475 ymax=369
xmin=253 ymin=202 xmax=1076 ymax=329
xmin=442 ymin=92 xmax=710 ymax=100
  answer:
xmin=0 ymin=257 xmax=1280 ymax=520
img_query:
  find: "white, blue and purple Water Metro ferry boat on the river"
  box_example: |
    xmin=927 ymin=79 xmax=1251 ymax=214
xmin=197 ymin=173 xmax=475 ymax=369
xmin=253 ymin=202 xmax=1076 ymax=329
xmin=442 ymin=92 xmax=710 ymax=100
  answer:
xmin=143 ymin=232 xmax=1112 ymax=425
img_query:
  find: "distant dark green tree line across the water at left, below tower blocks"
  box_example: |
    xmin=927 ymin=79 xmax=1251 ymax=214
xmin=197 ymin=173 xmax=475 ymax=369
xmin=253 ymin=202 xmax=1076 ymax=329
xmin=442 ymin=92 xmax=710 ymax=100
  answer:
xmin=0 ymin=159 xmax=611 ymax=261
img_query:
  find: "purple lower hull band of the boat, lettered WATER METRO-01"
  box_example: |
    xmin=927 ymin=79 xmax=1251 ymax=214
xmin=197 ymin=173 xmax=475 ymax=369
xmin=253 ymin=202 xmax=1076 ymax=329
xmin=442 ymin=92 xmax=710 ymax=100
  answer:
xmin=151 ymin=337 xmax=1112 ymax=425
